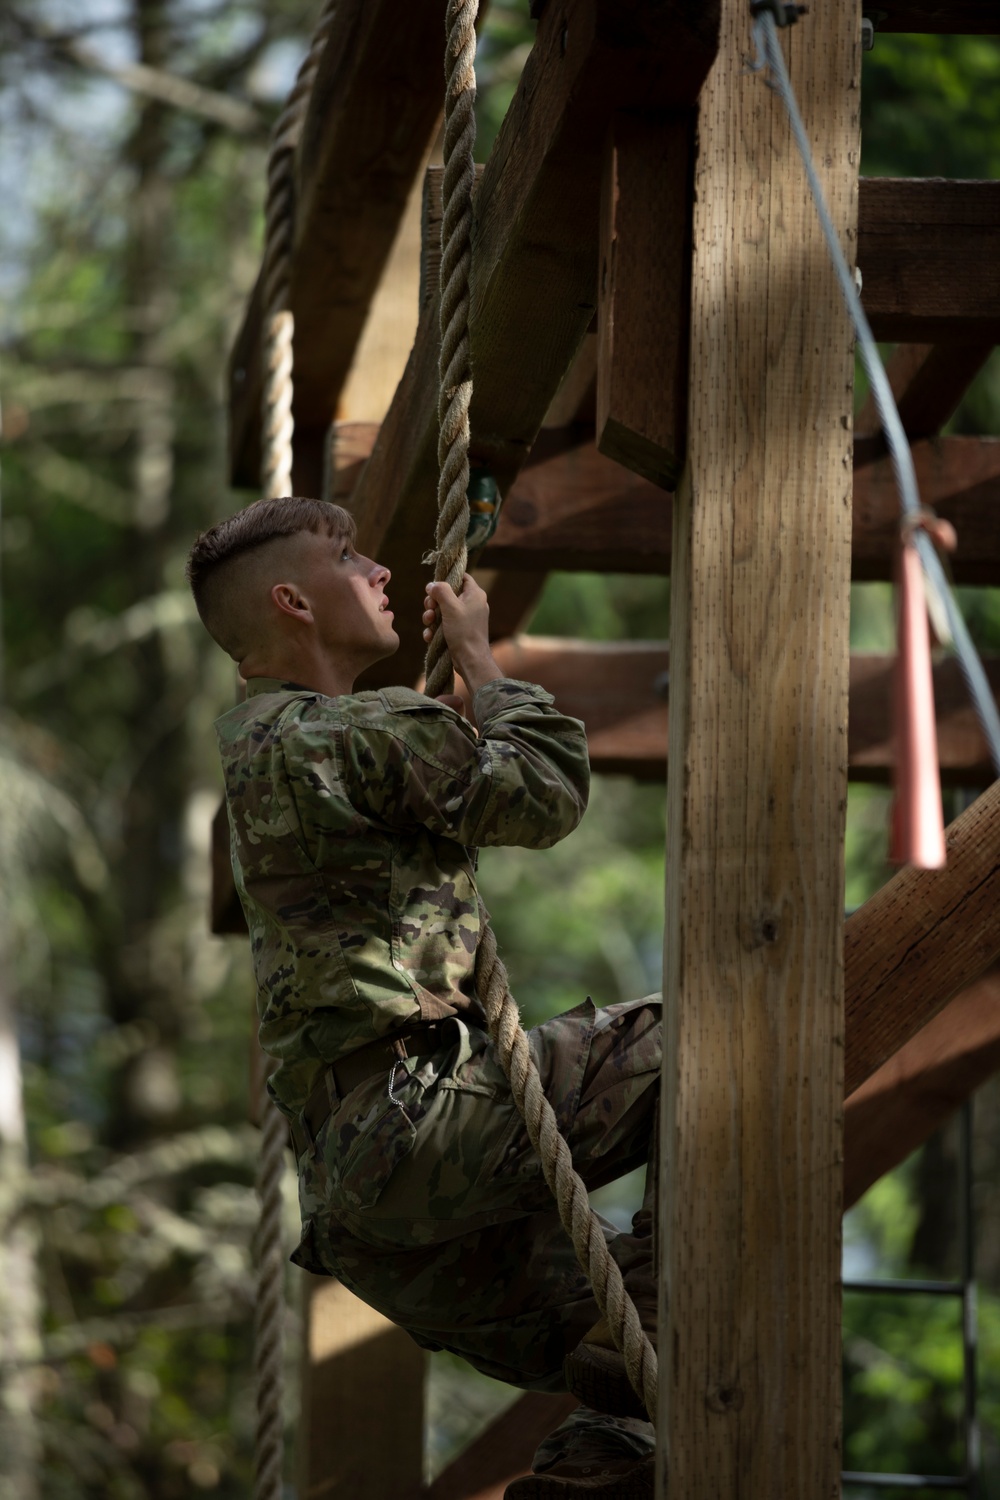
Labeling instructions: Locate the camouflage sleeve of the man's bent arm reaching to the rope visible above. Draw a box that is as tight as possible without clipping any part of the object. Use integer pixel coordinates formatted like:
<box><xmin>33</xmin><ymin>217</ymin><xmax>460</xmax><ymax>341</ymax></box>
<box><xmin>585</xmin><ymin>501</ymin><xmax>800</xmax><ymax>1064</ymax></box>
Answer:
<box><xmin>343</xmin><ymin>678</ymin><xmax>591</xmax><ymax>849</ymax></box>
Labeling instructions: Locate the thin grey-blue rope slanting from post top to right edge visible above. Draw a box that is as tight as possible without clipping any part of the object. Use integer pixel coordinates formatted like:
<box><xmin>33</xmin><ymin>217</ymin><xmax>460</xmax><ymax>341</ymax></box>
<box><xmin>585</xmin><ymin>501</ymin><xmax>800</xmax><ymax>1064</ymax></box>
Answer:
<box><xmin>751</xmin><ymin>0</ymin><xmax>1000</xmax><ymax>776</ymax></box>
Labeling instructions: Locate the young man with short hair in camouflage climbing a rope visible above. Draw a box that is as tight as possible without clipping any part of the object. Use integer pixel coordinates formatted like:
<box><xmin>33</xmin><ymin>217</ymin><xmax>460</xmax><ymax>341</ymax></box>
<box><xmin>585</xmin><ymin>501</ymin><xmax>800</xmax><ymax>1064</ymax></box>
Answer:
<box><xmin>189</xmin><ymin>500</ymin><xmax>660</xmax><ymax>1500</ymax></box>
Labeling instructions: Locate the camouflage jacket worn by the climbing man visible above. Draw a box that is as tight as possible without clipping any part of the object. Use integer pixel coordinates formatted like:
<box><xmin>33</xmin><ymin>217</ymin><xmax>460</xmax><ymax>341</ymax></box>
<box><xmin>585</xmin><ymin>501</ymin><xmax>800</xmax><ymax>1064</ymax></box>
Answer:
<box><xmin>216</xmin><ymin>678</ymin><xmax>589</xmax><ymax>1115</ymax></box>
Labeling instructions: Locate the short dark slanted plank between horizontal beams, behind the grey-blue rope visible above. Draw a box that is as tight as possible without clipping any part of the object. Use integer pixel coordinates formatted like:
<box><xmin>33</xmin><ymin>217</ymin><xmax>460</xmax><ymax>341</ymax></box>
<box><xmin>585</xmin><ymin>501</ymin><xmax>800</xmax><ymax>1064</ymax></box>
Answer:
<box><xmin>855</xmin><ymin>342</ymin><xmax>993</xmax><ymax>443</ymax></box>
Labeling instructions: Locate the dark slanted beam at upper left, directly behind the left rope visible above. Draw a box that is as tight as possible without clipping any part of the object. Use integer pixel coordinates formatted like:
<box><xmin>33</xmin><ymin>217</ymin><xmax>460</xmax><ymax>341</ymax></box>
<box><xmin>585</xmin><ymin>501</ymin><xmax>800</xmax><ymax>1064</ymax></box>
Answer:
<box><xmin>229</xmin><ymin>0</ymin><xmax>444</xmax><ymax>486</ymax></box>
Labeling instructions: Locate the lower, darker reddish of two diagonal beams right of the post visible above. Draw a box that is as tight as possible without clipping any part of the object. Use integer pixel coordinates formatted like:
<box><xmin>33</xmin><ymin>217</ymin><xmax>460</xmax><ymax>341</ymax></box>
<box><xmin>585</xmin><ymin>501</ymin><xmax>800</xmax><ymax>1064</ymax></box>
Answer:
<box><xmin>844</xmin><ymin>969</ymin><xmax>1000</xmax><ymax>1209</ymax></box>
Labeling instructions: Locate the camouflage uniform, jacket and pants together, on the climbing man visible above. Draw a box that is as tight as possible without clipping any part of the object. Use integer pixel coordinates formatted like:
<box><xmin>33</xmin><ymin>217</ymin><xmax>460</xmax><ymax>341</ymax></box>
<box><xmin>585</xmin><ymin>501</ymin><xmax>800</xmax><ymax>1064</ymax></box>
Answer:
<box><xmin>217</xmin><ymin>680</ymin><xmax>660</xmax><ymax>1391</ymax></box>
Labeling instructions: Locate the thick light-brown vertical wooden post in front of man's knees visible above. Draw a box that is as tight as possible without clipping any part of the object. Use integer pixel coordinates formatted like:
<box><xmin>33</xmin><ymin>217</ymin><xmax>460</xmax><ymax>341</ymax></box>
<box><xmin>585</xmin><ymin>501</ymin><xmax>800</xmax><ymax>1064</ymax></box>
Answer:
<box><xmin>658</xmin><ymin>0</ymin><xmax>861</xmax><ymax>1500</ymax></box>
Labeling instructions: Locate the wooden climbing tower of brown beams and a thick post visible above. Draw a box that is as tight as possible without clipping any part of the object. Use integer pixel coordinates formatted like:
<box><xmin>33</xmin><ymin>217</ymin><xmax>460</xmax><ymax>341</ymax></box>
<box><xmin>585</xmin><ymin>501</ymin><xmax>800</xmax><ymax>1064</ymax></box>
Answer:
<box><xmin>216</xmin><ymin>0</ymin><xmax>1000</xmax><ymax>1500</ymax></box>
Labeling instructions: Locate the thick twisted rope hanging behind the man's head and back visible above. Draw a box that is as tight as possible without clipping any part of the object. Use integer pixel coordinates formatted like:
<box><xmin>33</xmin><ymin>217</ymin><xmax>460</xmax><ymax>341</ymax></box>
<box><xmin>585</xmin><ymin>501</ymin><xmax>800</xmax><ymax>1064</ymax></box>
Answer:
<box><xmin>253</xmin><ymin>11</ymin><xmax>337</xmax><ymax>1500</ymax></box>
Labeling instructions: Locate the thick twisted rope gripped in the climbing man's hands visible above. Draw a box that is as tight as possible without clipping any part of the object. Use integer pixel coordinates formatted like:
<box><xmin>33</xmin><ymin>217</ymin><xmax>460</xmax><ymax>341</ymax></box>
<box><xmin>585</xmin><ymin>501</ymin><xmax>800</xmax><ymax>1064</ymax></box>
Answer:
<box><xmin>424</xmin><ymin>0</ymin><xmax>657</xmax><ymax>1419</ymax></box>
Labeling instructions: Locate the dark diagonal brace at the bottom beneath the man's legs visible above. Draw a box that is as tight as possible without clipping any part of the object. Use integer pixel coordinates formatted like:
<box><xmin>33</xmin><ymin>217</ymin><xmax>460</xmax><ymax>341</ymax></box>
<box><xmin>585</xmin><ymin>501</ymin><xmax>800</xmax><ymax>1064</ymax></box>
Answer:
<box><xmin>406</xmin><ymin>1391</ymin><xmax>579</xmax><ymax>1500</ymax></box>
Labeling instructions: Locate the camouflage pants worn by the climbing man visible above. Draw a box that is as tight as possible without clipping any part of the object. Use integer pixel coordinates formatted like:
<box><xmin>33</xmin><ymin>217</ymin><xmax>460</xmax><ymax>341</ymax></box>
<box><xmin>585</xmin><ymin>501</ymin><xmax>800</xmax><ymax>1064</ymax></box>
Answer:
<box><xmin>294</xmin><ymin>996</ymin><xmax>661</xmax><ymax>1391</ymax></box>
